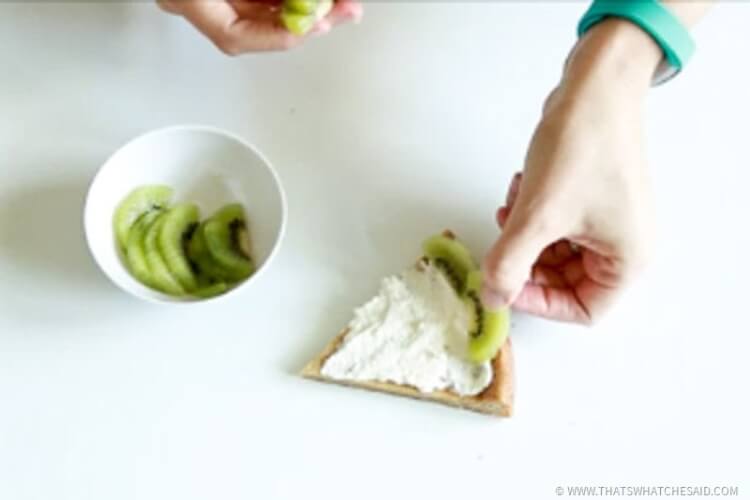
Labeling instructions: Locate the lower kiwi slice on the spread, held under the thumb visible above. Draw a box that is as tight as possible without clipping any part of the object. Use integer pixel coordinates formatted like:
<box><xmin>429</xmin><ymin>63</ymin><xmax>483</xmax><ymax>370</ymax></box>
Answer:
<box><xmin>464</xmin><ymin>270</ymin><xmax>510</xmax><ymax>363</ymax></box>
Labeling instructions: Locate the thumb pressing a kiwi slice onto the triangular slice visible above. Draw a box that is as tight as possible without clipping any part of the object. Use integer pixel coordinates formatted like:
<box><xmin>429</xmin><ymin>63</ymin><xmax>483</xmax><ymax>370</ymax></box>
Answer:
<box><xmin>482</xmin><ymin>211</ymin><xmax>556</xmax><ymax>309</ymax></box>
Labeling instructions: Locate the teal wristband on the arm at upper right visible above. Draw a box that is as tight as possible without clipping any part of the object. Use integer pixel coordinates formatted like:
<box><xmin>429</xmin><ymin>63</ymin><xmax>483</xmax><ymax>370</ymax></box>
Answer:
<box><xmin>578</xmin><ymin>0</ymin><xmax>695</xmax><ymax>83</ymax></box>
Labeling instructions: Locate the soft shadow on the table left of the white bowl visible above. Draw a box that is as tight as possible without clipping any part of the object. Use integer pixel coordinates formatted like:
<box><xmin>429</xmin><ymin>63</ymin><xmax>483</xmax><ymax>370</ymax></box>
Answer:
<box><xmin>0</xmin><ymin>178</ymin><xmax>123</xmax><ymax>320</ymax></box>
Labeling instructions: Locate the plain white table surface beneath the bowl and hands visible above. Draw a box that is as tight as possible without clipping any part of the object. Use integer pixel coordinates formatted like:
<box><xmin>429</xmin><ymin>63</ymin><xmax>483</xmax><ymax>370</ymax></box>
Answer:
<box><xmin>0</xmin><ymin>2</ymin><xmax>750</xmax><ymax>500</ymax></box>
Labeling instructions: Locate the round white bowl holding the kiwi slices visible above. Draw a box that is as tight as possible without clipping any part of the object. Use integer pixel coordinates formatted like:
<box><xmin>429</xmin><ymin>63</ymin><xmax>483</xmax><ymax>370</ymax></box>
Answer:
<box><xmin>84</xmin><ymin>126</ymin><xmax>286</xmax><ymax>303</ymax></box>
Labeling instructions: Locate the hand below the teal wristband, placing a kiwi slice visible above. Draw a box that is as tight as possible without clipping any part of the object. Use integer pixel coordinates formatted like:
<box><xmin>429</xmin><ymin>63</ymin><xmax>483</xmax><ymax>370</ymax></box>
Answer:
<box><xmin>482</xmin><ymin>21</ymin><xmax>660</xmax><ymax>323</ymax></box>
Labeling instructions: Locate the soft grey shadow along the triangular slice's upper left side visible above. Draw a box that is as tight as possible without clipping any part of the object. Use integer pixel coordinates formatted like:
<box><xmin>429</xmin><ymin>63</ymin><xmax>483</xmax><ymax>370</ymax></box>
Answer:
<box><xmin>284</xmin><ymin>188</ymin><xmax>498</xmax><ymax>374</ymax></box>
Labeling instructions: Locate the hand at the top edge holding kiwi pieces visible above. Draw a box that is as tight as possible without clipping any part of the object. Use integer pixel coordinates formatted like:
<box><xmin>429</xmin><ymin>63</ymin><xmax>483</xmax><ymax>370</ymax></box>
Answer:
<box><xmin>157</xmin><ymin>0</ymin><xmax>362</xmax><ymax>56</ymax></box>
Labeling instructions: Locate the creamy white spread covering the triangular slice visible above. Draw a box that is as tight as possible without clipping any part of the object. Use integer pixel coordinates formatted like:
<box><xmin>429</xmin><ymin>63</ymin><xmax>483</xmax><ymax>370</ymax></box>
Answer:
<box><xmin>321</xmin><ymin>264</ymin><xmax>492</xmax><ymax>396</ymax></box>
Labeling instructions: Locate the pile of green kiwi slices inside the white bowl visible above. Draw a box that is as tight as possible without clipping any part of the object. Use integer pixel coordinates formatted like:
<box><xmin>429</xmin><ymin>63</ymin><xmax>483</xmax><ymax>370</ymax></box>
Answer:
<box><xmin>114</xmin><ymin>185</ymin><xmax>255</xmax><ymax>297</ymax></box>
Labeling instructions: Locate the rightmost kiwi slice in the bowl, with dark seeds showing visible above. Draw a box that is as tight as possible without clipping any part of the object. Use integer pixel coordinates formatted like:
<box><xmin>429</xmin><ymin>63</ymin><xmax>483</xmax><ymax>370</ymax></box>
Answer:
<box><xmin>203</xmin><ymin>203</ymin><xmax>255</xmax><ymax>281</ymax></box>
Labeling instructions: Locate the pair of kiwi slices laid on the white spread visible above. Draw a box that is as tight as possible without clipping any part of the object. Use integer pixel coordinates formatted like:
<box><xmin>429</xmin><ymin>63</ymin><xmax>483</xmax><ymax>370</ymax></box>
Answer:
<box><xmin>422</xmin><ymin>231</ymin><xmax>510</xmax><ymax>363</ymax></box>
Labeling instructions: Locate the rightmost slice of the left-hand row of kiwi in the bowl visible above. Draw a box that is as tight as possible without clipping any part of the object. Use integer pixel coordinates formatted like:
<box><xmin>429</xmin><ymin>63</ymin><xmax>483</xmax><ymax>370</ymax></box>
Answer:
<box><xmin>157</xmin><ymin>203</ymin><xmax>200</xmax><ymax>292</ymax></box>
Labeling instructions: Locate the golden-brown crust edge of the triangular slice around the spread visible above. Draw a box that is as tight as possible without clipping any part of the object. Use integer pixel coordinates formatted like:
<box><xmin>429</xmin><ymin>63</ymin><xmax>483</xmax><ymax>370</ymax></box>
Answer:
<box><xmin>301</xmin><ymin>248</ymin><xmax>514</xmax><ymax>417</ymax></box>
